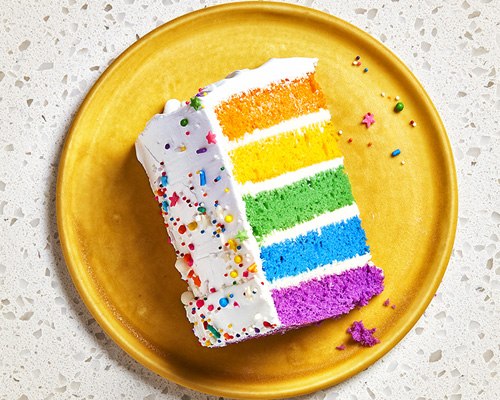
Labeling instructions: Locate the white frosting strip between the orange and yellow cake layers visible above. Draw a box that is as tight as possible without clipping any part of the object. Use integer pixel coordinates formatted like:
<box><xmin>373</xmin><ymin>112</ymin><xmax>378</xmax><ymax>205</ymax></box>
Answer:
<box><xmin>228</xmin><ymin>109</ymin><xmax>331</xmax><ymax>150</ymax></box>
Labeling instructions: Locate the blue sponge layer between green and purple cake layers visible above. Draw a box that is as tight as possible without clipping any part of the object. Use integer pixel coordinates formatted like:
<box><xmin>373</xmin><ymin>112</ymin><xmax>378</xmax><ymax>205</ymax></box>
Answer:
<box><xmin>260</xmin><ymin>216</ymin><xmax>370</xmax><ymax>282</ymax></box>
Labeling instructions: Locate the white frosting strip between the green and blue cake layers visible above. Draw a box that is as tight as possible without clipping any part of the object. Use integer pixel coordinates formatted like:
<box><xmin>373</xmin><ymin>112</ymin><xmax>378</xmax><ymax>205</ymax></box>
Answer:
<box><xmin>261</xmin><ymin>203</ymin><xmax>359</xmax><ymax>247</ymax></box>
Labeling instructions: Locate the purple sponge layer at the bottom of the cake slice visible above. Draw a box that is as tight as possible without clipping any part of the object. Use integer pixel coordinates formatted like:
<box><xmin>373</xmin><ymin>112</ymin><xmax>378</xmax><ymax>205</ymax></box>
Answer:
<box><xmin>272</xmin><ymin>264</ymin><xmax>384</xmax><ymax>328</ymax></box>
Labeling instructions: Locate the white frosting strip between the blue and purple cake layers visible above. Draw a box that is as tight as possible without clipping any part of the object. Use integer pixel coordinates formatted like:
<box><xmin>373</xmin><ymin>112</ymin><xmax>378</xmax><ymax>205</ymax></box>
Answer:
<box><xmin>271</xmin><ymin>253</ymin><xmax>371</xmax><ymax>289</ymax></box>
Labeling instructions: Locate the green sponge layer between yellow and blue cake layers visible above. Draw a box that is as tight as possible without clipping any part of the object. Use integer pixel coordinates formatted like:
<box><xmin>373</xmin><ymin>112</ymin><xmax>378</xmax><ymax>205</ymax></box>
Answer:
<box><xmin>243</xmin><ymin>166</ymin><xmax>354</xmax><ymax>240</ymax></box>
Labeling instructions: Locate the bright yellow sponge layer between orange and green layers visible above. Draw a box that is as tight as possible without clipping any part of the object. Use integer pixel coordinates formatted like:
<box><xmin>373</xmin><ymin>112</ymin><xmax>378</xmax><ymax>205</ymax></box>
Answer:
<box><xmin>229</xmin><ymin>122</ymin><xmax>342</xmax><ymax>183</ymax></box>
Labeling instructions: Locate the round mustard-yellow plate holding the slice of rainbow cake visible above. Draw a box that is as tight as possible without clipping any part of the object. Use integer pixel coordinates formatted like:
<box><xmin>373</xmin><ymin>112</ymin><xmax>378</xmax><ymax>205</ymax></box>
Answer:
<box><xmin>57</xmin><ymin>2</ymin><xmax>457</xmax><ymax>398</ymax></box>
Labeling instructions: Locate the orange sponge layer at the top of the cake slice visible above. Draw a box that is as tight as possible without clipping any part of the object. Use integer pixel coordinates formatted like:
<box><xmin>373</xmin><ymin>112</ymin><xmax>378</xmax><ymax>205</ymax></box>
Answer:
<box><xmin>215</xmin><ymin>73</ymin><xmax>327</xmax><ymax>140</ymax></box>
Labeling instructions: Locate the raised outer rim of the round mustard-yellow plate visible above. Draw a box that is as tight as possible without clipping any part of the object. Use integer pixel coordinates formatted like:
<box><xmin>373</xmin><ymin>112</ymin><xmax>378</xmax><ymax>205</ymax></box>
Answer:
<box><xmin>56</xmin><ymin>1</ymin><xmax>458</xmax><ymax>399</ymax></box>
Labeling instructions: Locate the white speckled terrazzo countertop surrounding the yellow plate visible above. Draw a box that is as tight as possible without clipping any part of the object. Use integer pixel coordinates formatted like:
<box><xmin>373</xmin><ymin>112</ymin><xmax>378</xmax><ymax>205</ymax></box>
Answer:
<box><xmin>0</xmin><ymin>0</ymin><xmax>500</xmax><ymax>400</ymax></box>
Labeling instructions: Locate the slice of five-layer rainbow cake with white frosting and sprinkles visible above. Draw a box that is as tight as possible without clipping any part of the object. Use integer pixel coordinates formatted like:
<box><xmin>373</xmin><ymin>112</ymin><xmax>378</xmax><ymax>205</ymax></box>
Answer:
<box><xmin>136</xmin><ymin>58</ymin><xmax>384</xmax><ymax>347</ymax></box>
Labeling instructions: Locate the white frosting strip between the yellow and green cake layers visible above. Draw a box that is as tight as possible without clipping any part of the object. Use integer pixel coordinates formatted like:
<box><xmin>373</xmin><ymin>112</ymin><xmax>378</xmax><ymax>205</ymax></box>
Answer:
<box><xmin>239</xmin><ymin>157</ymin><xmax>344</xmax><ymax>196</ymax></box>
